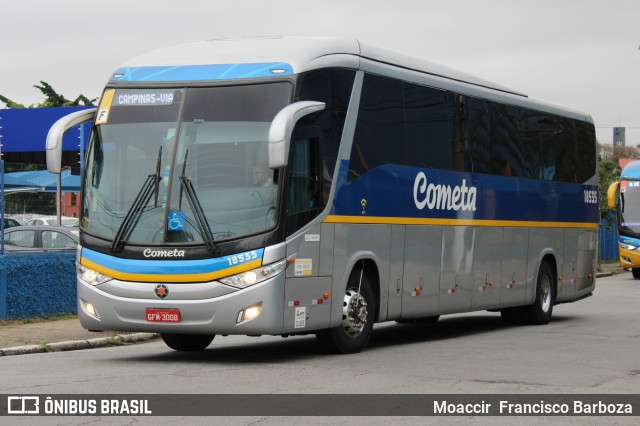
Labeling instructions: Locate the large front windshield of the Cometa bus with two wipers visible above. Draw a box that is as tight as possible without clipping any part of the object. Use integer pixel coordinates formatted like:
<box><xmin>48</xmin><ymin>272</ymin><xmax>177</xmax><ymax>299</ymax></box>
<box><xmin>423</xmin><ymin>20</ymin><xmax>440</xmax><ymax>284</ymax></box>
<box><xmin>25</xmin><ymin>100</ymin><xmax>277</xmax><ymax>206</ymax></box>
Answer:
<box><xmin>81</xmin><ymin>82</ymin><xmax>292</xmax><ymax>245</ymax></box>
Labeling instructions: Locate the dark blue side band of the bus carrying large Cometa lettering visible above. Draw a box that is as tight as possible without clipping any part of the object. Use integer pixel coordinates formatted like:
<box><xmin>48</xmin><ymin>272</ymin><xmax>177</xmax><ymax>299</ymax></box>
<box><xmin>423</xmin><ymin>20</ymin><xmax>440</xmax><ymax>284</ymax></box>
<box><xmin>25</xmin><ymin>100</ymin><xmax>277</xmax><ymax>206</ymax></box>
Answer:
<box><xmin>330</xmin><ymin>160</ymin><xmax>599</xmax><ymax>226</ymax></box>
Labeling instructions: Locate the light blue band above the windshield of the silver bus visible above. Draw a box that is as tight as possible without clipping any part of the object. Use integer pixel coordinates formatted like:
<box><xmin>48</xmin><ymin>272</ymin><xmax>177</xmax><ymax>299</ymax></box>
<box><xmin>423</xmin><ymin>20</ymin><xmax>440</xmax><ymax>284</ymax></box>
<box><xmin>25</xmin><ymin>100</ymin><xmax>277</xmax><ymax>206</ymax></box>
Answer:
<box><xmin>111</xmin><ymin>62</ymin><xmax>293</xmax><ymax>82</ymax></box>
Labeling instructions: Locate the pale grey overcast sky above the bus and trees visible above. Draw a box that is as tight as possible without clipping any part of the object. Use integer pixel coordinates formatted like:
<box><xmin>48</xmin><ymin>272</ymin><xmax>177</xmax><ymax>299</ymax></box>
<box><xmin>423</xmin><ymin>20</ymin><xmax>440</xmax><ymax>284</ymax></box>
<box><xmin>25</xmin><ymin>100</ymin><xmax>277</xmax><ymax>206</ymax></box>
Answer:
<box><xmin>0</xmin><ymin>0</ymin><xmax>640</xmax><ymax>146</ymax></box>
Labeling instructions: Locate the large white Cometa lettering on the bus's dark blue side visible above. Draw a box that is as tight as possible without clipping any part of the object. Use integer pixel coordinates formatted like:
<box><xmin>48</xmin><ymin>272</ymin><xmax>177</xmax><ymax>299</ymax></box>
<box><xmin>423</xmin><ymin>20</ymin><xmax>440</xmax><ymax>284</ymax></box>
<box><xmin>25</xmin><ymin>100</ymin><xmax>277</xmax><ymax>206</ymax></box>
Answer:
<box><xmin>413</xmin><ymin>172</ymin><xmax>478</xmax><ymax>212</ymax></box>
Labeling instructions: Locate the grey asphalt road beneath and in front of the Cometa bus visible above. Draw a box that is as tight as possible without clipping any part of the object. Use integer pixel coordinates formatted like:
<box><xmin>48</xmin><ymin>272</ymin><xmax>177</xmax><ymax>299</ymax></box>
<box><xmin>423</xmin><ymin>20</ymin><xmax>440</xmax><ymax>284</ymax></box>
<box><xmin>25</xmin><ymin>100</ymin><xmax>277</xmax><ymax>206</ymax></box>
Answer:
<box><xmin>0</xmin><ymin>273</ymin><xmax>640</xmax><ymax>425</ymax></box>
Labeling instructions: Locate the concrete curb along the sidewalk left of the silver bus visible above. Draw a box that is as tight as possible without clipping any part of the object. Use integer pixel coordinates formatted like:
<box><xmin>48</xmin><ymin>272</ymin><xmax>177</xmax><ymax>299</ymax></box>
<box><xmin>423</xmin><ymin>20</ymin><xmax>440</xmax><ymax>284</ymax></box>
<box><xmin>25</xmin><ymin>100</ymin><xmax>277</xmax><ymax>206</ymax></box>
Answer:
<box><xmin>0</xmin><ymin>333</ymin><xmax>160</xmax><ymax>356</ymax></box>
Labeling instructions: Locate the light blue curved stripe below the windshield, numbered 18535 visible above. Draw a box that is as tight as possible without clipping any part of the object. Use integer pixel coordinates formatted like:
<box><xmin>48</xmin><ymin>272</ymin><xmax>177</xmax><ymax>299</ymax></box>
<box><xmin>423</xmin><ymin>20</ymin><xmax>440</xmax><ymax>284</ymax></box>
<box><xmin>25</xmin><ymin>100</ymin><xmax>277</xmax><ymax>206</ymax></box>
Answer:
<box><xmin>82</xmin><ymin>248</ymin><xmax>264</xmax><ymax>276</ymax></box>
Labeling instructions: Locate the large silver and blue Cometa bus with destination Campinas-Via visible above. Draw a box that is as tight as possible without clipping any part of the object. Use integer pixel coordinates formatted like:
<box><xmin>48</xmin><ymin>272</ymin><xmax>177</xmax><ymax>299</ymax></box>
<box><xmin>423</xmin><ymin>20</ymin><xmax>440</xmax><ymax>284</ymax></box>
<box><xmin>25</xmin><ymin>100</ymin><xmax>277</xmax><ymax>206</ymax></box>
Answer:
<box><xmin>47</xmin><ymin>37</ymin><xmax>598</xmax><ymax>353</ymax></box>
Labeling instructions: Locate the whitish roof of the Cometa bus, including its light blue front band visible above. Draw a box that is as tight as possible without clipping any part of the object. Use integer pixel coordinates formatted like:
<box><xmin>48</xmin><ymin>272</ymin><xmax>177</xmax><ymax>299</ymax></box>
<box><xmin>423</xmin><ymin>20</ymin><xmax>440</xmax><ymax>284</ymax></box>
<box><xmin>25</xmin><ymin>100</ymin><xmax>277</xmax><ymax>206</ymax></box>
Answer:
<box><xmin>110</xmin><ymin>36</ymin><xmax>593</xmax><ymax>123</ymax></box>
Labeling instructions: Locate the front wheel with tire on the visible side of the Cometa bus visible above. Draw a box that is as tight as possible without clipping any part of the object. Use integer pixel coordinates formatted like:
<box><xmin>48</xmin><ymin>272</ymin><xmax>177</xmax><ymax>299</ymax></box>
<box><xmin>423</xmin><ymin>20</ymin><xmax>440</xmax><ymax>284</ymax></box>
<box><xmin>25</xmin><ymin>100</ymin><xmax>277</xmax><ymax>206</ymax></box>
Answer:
<box><xmin>316</xmin><ymin>273</ymin><xmax>376</xmax><ymax>354</ymax></box>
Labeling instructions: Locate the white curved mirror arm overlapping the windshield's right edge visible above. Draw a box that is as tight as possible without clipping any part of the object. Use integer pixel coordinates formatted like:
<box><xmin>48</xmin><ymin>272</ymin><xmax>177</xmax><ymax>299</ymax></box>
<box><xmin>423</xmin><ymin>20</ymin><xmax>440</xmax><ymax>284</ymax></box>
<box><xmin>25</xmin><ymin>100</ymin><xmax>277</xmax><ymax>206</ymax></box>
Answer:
<box><xmin>268</xmin><ymin>101</ymin><xmax>325</xmax><ymax>169</ymax></box>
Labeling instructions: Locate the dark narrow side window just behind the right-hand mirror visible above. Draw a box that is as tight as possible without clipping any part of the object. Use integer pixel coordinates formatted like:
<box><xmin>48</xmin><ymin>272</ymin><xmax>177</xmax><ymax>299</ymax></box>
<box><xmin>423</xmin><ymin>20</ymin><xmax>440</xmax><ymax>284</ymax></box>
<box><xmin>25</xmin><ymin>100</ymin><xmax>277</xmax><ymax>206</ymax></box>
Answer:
<box><xmin>286</xmin><ymin>130</ymin><xmax>324</xmax><ymax>235</ymax></box>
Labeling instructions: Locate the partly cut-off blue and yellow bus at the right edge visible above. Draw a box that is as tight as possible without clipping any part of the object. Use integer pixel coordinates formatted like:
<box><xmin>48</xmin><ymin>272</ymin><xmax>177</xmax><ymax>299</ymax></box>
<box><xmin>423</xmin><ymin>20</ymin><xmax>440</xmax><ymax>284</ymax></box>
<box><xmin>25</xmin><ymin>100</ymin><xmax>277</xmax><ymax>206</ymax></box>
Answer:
<box><xmin>607</xmin><ymin>161</ymin><xmax>640</xmax><ymax>279</ymax></box>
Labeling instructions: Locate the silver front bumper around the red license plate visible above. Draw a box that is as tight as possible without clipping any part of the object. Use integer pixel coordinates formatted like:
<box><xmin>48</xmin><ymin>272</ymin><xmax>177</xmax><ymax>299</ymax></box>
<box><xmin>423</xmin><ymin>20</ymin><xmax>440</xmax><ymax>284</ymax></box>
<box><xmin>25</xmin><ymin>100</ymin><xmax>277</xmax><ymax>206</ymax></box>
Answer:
<box><xmin>78</xmin><ymin>273</ymin><xmax>285</xmax><ymax>335</ymax></box>
